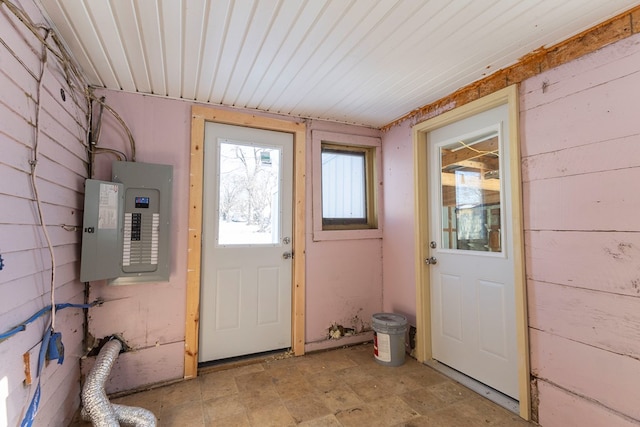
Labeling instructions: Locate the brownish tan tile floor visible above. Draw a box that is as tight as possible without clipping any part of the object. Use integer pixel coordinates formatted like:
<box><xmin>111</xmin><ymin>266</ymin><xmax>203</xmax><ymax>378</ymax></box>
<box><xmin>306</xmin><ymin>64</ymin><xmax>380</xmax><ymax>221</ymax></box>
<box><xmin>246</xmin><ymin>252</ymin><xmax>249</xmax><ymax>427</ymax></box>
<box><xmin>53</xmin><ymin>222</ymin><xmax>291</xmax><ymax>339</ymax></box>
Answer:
<box><xmin>72</xmin><ymin>344</ymin><xmax>534</xmax><ymax>427</ymax></box>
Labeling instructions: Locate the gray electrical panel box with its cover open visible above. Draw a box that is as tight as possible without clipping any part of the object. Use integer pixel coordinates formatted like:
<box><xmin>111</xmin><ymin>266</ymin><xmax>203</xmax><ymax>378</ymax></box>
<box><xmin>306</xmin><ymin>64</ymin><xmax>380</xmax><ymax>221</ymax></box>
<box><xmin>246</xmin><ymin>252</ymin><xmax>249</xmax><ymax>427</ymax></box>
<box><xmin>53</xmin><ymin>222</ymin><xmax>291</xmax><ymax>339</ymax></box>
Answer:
<box><xmin>80</xmin><ymin>162</ymin><xmax>173</xmax><ymax>285</ymax></box>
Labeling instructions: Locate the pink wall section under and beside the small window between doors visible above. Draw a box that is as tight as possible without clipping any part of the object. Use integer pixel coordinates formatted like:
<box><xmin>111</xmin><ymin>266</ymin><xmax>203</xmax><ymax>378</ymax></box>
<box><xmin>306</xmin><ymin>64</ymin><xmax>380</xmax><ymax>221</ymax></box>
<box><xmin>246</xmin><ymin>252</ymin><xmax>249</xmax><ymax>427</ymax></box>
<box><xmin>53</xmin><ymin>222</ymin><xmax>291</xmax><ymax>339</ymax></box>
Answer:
<box><xmin>305</xmin><ymin>120</ymin><xmax>384</xmax><ymax>351</ymax></box>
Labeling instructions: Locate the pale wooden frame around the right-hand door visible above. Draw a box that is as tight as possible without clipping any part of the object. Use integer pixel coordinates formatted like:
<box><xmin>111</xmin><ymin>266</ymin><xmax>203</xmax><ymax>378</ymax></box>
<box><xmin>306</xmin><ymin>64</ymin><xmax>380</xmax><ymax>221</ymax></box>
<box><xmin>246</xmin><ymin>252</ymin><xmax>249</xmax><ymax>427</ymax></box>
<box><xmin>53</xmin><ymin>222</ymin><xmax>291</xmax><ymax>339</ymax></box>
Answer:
<box><xmin>413</xmin><ymin>85</ymin><xmax>531</xmax><ymax>420</ymax></box>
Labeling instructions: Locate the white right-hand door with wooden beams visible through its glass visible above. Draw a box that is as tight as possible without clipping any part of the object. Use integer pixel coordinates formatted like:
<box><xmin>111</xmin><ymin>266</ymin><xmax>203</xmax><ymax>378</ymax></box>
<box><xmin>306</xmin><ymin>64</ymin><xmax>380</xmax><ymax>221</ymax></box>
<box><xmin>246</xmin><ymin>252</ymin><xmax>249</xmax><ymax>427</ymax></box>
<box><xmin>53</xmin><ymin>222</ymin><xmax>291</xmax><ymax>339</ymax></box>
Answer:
<box><xmin>425</xmin><ymin>104</ymin><xmax>518</xmax><ymax>400</ymax></box>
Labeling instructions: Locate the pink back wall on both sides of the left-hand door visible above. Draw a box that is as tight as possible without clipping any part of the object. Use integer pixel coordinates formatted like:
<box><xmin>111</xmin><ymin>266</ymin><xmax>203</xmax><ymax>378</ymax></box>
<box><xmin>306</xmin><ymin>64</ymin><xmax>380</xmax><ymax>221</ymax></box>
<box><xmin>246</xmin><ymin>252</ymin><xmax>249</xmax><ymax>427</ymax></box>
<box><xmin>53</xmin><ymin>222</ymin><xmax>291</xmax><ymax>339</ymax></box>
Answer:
<box><xmin>83</xmin><ymin>91</ymin><xmax>382</xmax><ymax>392</ymax></box>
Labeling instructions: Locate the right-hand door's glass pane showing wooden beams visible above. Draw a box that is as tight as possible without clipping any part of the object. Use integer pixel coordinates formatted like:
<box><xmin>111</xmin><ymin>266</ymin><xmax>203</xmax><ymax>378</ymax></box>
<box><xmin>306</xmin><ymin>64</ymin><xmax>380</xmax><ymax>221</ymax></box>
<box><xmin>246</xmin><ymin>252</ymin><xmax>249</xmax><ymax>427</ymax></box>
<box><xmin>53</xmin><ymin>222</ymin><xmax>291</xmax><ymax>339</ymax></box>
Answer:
<box><xmin>440</xmin><ymin>132</ymin><xmax>502</xmax><ymax>252</ymax></box>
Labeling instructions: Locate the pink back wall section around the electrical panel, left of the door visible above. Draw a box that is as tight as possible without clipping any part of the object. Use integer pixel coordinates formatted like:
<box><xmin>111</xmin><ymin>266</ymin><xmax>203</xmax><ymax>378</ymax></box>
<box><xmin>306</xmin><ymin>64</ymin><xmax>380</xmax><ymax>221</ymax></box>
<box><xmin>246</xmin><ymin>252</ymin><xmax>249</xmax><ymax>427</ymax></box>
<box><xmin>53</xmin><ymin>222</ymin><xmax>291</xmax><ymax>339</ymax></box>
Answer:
<box><xmin>82</xmin><ymin>91</ymin><xmax>191</xmax><ymax>392</ymax></box>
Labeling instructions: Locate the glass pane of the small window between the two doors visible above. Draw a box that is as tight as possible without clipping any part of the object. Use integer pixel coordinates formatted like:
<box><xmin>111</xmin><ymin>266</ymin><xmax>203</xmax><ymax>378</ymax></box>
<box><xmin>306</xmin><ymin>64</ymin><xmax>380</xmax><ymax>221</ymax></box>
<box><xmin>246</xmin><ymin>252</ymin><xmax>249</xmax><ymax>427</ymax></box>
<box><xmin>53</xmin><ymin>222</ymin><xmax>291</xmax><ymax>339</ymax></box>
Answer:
<box><xmin>322</xmin><ymin>150</ymin><xmax>367</xmax><ymax>222</ymax></box>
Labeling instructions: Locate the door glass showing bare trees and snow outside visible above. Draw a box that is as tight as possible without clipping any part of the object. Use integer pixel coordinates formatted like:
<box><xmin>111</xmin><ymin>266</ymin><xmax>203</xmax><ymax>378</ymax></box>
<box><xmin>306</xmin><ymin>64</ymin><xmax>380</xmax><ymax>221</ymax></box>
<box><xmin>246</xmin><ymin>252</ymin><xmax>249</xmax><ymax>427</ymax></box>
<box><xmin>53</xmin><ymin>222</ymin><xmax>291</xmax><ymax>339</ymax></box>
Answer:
<box><xmin>218</xmin><ymin>140</ymin><xmax>280</xmax><ymax>245</ymax></box>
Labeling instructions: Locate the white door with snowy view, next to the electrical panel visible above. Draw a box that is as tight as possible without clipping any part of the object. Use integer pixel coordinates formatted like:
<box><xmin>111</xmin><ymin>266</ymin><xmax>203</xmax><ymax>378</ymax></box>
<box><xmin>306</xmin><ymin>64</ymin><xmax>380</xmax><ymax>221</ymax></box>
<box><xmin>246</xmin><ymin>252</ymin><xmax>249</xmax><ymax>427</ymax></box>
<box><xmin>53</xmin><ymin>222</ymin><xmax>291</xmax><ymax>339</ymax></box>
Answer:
<box><xmin>198</xmin><ymin>123</ymin><xmax>293</xmax><ymax>362</ymax></box>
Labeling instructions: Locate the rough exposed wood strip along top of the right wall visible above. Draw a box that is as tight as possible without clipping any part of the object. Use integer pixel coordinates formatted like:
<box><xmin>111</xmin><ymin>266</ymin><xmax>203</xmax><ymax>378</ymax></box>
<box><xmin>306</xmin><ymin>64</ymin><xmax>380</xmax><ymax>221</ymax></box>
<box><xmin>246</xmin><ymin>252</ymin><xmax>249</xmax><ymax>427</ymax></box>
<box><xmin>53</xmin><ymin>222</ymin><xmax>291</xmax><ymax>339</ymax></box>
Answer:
<box><xmin>381</xmin><ymin>6</ymin><xmax>640</xmax><ymax>132</ymax></box>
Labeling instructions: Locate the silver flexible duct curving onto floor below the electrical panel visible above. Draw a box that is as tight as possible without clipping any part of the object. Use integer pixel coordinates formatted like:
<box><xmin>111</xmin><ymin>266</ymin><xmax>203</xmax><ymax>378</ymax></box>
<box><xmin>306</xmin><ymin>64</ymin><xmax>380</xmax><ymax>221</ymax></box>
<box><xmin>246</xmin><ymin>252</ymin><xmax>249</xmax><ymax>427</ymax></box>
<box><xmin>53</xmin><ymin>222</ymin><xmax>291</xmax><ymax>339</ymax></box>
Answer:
<box><xmin>82</xmin><ymin>339</ymin><xmax>156</xmax><ymax>427</ymax></box>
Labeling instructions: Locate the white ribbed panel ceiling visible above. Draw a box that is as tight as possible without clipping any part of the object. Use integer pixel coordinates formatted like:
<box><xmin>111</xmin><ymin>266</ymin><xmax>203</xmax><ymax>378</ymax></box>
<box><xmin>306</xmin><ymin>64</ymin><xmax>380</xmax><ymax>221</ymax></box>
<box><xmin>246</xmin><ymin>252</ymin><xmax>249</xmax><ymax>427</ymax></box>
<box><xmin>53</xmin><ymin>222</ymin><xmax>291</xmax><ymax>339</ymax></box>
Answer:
<box><xmin>40</xmin><ymin>0</ymin><xmax>640</xmax><ymax>127</ymax></box>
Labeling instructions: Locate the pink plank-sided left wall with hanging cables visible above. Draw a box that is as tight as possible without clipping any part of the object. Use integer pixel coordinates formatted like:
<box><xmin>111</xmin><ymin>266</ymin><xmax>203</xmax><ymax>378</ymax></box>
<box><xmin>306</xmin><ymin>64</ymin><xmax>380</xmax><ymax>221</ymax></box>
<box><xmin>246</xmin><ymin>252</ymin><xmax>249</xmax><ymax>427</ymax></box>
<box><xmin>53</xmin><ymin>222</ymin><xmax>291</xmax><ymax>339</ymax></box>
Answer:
<box><xmin>0</xmin><ymin>0</ymin><xmax>87</xmax><ymax>426</ymax></box>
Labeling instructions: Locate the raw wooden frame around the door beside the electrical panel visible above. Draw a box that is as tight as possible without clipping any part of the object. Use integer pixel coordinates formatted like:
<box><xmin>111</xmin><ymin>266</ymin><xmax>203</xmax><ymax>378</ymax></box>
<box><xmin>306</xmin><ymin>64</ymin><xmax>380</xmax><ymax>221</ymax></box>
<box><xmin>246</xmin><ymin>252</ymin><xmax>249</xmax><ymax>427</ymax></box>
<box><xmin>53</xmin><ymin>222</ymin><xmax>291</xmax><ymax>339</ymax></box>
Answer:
<box><xmin>184</xmin><ymin>105</ymin><xmax>306</xmax><ymax>378</ymax></box>
